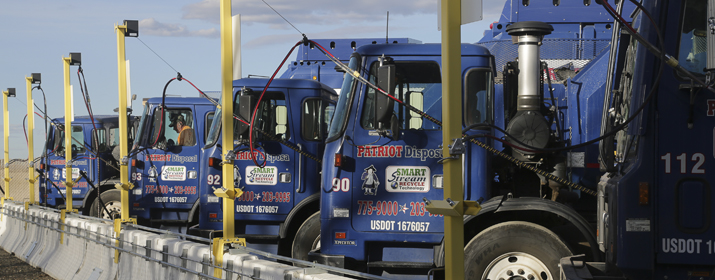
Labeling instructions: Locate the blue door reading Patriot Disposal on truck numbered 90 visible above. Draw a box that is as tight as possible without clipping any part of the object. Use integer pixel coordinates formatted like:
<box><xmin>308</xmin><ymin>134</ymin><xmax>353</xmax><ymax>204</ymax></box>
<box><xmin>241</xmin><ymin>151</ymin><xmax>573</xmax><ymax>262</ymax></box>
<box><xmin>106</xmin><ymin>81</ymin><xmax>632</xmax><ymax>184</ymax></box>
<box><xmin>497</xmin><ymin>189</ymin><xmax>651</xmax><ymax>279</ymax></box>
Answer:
<box><xmin>350</xmin><ymin>58</ymin><xmax>444</xmax><ymax>233</ymax></box>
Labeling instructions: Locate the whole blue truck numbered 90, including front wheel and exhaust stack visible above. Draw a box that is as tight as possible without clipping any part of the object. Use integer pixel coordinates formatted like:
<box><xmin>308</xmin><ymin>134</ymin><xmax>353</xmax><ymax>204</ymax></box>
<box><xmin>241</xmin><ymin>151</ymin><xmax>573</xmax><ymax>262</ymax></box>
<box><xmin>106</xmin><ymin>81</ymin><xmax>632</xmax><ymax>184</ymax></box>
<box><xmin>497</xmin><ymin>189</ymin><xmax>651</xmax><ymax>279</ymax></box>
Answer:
<box><xmin>309</xmin><ymin>3</ymin><xmax>636</xmax><ymax>279</ymax></box>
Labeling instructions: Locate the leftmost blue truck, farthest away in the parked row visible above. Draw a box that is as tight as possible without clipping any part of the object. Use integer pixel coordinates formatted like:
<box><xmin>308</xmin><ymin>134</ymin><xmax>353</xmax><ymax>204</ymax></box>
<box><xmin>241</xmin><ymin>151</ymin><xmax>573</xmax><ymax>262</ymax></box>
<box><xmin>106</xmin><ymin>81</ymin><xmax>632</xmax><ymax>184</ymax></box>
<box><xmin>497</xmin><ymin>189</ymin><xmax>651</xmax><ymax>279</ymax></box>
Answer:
<box><xmin>39</xmin><ymin>115</ymin><xmax>137</xmax><ymax>217</ymax></box>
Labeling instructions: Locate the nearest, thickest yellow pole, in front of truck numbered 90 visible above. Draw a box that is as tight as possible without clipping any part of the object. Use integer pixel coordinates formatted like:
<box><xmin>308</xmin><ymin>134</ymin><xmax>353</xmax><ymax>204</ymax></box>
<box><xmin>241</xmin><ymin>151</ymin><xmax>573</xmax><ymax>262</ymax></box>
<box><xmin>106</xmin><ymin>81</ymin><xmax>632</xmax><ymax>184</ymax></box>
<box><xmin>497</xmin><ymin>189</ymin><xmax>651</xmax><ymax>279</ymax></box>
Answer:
<box><xmin>441</xmin><ymin>0</ymin><xmax>464</xmax><ymax>279</ymax></box>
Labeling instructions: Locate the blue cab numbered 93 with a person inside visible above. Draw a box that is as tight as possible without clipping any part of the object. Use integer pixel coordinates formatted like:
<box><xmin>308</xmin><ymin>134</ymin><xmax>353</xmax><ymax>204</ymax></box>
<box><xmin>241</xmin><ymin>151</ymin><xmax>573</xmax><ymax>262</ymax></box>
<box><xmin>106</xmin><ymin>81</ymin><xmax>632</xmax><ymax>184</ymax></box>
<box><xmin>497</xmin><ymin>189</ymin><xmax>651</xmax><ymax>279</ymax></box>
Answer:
<box><xmin>129</xmin><ymin>97</ymin><xmax>216</xmax><ymax>233</ymax></box>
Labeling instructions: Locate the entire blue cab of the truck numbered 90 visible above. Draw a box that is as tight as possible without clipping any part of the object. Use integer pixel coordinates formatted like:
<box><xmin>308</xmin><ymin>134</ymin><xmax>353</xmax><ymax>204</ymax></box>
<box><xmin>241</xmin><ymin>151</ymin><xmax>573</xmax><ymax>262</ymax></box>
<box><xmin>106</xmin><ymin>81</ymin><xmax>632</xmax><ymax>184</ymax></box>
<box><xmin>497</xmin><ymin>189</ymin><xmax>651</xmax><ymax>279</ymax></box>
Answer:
<box><xmin>311</xmin><ymin>44</ymin><xmax>494</xmax><ymax>271</ymax></box>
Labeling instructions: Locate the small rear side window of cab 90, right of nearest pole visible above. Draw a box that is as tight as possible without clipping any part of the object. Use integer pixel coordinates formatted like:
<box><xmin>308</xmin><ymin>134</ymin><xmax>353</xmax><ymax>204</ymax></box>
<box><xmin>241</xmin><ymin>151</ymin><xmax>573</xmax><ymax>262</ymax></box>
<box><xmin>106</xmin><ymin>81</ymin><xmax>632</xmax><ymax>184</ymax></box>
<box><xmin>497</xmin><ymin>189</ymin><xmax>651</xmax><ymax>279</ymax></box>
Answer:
<box><xmin>464</xmin><ymin>69</ymin><xmax>493</xmax><ymax>126</ymax></box>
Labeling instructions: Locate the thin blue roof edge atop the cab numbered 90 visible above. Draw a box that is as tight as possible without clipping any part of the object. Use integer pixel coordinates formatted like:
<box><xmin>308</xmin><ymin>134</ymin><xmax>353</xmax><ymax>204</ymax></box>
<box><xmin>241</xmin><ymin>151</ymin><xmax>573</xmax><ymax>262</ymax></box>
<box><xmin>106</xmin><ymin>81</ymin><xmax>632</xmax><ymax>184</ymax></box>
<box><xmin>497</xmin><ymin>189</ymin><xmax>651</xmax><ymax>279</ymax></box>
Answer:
<box><xmin>358</xmin><ymin>43</ymin><xmax>491</xmax><ymax>56</ymax></box>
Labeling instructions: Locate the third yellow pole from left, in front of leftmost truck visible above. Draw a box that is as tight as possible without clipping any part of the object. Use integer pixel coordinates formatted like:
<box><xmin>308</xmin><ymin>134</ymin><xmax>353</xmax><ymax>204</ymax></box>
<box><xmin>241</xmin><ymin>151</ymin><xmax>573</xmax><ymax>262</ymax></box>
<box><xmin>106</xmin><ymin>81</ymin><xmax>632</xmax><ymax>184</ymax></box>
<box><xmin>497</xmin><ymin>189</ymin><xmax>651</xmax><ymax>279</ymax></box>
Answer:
<box><xmin>62</xmin><ymin>57</ymin><xmax>74</xmax><ymax>212</ymax></box>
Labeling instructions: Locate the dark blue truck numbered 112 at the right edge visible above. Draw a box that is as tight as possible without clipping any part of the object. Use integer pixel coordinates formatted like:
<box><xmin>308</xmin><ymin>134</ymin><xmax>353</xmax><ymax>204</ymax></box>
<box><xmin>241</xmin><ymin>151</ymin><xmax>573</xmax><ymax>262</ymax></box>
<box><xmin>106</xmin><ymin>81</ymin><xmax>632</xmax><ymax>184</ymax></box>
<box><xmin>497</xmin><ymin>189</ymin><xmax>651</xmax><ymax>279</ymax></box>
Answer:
<box><xmin>561</xmin><ymin>0</ymin><xmax>715</xmax><ymax>279</ymax></box>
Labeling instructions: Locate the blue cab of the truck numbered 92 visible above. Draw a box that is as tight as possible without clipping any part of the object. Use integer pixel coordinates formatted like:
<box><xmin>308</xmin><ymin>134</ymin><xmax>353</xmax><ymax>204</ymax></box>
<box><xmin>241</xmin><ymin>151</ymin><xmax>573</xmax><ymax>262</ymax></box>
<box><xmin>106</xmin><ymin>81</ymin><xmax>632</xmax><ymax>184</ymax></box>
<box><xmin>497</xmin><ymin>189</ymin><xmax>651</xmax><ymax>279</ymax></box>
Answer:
<box><xmin>198</xmin><ymin>78</ymin><xmax>337</xmax><ymax>258</ymax></box>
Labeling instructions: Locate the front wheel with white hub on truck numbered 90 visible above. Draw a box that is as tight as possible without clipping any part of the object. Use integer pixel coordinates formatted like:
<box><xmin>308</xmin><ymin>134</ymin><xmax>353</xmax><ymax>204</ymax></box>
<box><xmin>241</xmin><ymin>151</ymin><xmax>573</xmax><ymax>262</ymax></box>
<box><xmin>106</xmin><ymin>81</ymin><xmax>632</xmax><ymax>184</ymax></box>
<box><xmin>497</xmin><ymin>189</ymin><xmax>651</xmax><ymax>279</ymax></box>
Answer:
<box><xmin>464</xmin><ymin>221</ymin><xmax>572</xmax><ymax>280</ymax></box>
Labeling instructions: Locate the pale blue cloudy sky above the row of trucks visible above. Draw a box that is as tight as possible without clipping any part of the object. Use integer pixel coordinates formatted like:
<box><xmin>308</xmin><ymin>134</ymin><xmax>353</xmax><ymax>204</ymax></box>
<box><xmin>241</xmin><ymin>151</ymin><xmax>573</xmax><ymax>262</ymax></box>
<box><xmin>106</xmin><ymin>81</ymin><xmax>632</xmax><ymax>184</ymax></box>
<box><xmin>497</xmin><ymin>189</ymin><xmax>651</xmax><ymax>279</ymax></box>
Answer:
<box><xmin>0</xmin><ymin>0</ymin><xmax>507</xmax><ymax>159</ymax></box>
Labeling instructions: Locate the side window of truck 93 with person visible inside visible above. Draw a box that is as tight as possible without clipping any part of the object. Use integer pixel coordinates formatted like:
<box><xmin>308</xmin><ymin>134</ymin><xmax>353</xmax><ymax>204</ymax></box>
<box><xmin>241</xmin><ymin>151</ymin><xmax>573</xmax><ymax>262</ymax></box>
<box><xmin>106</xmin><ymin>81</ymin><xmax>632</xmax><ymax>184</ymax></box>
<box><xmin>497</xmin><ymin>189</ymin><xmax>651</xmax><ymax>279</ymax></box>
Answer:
<box><xmin>149</xmin><ymin>108</ymin><xmax>196</xmax><ymax>148</ymax></box>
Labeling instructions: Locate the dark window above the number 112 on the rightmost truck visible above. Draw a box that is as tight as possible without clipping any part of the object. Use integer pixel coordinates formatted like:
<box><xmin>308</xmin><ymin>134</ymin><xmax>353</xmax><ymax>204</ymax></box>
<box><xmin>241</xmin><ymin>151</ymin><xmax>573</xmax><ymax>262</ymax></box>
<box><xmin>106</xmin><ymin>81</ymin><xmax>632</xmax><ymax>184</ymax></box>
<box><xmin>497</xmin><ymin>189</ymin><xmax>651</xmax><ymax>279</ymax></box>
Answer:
<box><xmin>678</xmin><ymin>0</ymin><xmax>708</xmax><ymax>75</ymax></box>
